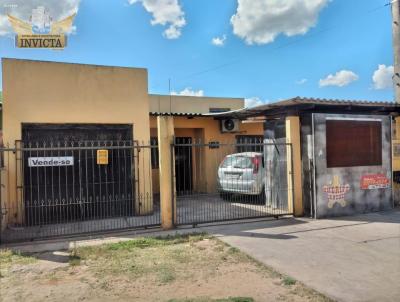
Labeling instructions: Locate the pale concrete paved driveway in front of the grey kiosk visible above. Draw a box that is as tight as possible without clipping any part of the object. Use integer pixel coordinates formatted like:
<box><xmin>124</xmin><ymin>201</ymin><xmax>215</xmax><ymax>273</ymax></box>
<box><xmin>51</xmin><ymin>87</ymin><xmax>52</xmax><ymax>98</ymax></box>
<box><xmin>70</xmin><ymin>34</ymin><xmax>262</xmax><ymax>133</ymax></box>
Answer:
<box><xmin>206</xmin><ymin>211</ymin><xmax>400</xmax><ymax>301</ymax></box>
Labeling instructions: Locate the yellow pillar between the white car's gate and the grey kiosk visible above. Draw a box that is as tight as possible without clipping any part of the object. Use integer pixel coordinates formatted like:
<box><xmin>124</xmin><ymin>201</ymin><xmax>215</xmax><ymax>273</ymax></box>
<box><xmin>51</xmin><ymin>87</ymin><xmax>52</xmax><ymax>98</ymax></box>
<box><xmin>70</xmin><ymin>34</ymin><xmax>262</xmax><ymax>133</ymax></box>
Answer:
<box><xmin>286</xmin><ymin>116</ymin><xmax>304</xmax><ymax>216</ymax></box>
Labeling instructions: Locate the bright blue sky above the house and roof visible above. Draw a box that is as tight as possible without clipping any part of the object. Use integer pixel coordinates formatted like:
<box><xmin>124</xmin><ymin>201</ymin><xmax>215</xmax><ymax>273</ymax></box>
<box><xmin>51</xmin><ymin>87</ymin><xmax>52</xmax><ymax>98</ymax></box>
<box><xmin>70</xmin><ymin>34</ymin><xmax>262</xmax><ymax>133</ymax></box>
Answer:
<box><xmin>0</xmin><ymin>0</ymin><xmax>393</xmax><ymax>104</ymax></box>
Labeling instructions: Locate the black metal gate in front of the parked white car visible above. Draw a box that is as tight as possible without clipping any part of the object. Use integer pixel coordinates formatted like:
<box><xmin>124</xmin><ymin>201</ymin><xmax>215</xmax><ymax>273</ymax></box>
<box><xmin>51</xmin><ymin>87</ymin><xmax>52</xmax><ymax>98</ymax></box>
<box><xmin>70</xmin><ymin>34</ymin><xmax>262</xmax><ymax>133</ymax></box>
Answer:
<box><xmin>171</xmin><ymin>138</ymin><xmax>293</xmax><ymax>225</ymax></box>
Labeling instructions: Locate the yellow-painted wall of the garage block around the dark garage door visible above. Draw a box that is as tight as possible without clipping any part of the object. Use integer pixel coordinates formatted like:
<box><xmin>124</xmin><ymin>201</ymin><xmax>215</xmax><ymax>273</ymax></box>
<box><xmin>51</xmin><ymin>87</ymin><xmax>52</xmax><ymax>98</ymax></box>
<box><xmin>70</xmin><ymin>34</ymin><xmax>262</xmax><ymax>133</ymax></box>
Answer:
<box><xmin>2</xmin><ymin>59</ymin><xmax>152</xmax><ymax>224</ymax></box>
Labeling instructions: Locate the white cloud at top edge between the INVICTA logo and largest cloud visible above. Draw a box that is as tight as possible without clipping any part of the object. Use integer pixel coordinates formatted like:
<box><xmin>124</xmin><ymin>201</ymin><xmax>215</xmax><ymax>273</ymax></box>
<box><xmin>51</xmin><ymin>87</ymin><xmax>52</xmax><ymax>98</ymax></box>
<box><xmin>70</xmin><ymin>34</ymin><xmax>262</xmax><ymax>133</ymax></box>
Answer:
<box><xmin>129</xmin><ymin>0</ymin><xmax>186</xmax><ymax>39</ymax></box>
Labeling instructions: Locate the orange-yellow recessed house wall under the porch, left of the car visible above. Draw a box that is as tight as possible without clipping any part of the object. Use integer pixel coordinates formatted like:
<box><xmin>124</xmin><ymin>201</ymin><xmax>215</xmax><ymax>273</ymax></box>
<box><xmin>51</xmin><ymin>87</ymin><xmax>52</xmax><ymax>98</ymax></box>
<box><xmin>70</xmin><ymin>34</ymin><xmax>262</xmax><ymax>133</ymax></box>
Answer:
<box><xmin>150</xmin><ymin>116</ymin><xmax>264</xmax><ymax>193</ymax></box>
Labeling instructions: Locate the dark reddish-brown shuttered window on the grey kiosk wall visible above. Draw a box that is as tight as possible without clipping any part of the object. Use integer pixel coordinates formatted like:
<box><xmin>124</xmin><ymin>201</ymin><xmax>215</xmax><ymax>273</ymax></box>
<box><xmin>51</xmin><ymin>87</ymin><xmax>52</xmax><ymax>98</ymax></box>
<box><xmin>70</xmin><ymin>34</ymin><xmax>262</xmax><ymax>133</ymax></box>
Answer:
<box><xmin>326</xmin><ymin>120</ymin><xmax>382</xmax><ymax>168</ymax></box>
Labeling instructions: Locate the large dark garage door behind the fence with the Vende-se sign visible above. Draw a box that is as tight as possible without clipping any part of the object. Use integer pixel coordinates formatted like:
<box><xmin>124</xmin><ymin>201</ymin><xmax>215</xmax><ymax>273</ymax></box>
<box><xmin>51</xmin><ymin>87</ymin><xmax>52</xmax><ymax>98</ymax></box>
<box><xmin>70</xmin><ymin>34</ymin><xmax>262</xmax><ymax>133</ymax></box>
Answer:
<box><xmin>22</xmin><ymin>124</ymin><xmax>134</xmax><ymax>225</ymax></box>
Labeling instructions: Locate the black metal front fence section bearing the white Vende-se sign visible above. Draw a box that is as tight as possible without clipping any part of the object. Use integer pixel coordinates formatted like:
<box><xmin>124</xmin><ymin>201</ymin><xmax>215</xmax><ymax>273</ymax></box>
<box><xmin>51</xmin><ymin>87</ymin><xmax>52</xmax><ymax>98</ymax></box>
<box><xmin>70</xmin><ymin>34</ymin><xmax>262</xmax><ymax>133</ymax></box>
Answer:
<box><xmin>0</xmin><ymin>140</ymin><xmax>161</xmax><ymax>242</ymax></box>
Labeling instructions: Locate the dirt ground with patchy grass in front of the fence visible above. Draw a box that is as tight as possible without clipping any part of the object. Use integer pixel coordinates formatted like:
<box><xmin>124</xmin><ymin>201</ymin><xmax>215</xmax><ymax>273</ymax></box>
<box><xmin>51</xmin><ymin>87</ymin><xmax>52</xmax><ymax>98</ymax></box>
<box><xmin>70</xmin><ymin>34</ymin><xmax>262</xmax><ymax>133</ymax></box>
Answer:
<box><xmin>0</xmin><ymin>235</ymin><xmax>329</xmax><ymax>302</ymax></box>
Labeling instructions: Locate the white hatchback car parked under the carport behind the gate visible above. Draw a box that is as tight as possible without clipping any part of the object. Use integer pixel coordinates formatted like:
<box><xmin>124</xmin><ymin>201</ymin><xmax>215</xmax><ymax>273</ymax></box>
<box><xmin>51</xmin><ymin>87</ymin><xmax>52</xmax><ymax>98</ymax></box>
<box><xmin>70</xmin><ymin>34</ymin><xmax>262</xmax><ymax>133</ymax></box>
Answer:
<box><xmin>218</xmin><ymin>152</ymin><xmax>265</xmax><ymax>199</ymax></box>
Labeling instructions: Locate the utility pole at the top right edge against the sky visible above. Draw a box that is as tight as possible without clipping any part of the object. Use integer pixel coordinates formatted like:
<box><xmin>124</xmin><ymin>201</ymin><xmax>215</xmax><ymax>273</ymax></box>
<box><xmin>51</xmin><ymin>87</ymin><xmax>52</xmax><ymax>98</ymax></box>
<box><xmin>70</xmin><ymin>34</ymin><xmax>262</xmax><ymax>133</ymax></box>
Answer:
<box><xmin>391</xmin><ymin>0</ymin><xmax>400</xmax><ymax>104</ymax></box>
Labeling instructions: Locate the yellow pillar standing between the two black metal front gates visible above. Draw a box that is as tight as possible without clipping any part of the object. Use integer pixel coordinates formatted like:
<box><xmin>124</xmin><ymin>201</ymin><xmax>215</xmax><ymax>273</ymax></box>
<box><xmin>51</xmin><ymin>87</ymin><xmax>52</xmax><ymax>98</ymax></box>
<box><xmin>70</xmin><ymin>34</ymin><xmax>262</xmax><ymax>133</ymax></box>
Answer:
<box><xmin>157</xmin><ymin>116</ymin><xmax>176</xmax><ymax>230</ymax></box>
